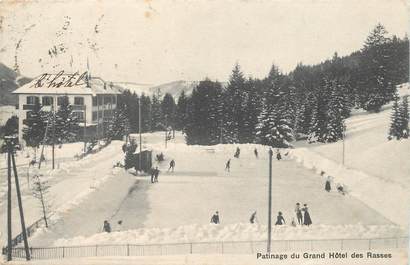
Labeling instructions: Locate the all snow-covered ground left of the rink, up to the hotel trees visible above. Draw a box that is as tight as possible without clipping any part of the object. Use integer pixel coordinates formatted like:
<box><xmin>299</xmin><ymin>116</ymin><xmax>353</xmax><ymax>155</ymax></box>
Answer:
<box><xmin>0</xmin><ymin>141</ymin><xmax>123</xmax><ymax>242</ymax></box>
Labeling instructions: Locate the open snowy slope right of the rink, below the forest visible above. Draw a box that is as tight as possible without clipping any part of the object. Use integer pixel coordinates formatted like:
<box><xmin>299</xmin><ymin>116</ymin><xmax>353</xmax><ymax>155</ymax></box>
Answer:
<box><xmin>292</xmin><ymin>86</ymin><xmax>410</xmax><ymax>229</ymax></box>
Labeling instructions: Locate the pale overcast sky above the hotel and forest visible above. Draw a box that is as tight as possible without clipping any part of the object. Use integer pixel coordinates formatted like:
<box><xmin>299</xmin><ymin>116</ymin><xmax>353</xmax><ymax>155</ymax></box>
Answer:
<box><xmin>0</xmin><ymin>0</ymin><xmax>409</xmax><ymax>84</ymax></box>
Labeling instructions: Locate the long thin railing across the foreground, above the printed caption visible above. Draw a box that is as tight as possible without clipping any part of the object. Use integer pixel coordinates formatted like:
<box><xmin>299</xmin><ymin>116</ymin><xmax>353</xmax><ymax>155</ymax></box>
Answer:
<box><xmin>3</xmin><ymin>237</ymin><xmax>409</xmax><ymax>259</ymax></box>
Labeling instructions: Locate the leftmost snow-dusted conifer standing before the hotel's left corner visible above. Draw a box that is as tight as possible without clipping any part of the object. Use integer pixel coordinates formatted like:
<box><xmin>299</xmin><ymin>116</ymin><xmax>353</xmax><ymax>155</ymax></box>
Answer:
<box><xmin>23</xmin><ymin>101</ymin><xmax>46</xmax><ymax>150</ymax></box>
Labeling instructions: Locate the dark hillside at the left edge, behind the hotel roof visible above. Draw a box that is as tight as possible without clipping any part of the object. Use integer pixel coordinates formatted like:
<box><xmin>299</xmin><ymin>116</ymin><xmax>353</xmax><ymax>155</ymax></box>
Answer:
<box><xmin>0</xmin><ymin>63</ymin><xmax>31</xmax><ymax>106</ymax></box>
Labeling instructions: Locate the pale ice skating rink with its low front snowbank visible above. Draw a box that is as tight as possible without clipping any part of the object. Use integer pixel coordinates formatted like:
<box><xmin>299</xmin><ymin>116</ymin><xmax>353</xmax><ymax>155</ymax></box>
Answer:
<box><xmin>20</xmin><ymin>133</ymin><xmax>403</xmax><ymax>246</ymax></box>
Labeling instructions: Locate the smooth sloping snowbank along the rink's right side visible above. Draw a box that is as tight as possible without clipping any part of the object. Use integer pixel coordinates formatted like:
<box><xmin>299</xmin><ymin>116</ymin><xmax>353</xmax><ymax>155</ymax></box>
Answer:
<box><xmin>290</xmin><ymin>148</ymin><xmax>410</xmax><ymax>229</ymax></box>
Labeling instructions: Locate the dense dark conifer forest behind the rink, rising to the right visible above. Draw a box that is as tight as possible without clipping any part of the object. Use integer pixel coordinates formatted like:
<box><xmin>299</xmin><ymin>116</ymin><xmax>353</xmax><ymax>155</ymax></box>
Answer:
<box><xmin>116</xmin><ymin>24</ymin><xmax>409</xmax><ymax>147</ymax></box>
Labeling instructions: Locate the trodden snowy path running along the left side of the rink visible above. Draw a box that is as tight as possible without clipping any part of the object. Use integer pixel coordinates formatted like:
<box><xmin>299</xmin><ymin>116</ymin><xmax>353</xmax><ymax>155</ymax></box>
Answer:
<box><xmin>0</xmin><ymin>141</ymin><xmax>123</xmax><ymax>242</ymax></box>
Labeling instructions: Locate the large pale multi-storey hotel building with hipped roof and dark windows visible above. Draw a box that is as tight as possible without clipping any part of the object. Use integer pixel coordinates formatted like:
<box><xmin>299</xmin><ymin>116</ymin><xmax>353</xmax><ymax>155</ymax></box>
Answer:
<box><xmin>13</xmin><ymin>73</ymin><xmax>120</xmax><ymax>143</ymax></box>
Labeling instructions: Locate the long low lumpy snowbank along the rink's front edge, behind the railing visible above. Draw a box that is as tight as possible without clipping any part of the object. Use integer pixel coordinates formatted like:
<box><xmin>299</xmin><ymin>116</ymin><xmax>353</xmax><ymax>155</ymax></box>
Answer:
<box><xmin>54</xmin><ymin>223</ymin><xmax>402</xmax><ymax>246</ymax></box>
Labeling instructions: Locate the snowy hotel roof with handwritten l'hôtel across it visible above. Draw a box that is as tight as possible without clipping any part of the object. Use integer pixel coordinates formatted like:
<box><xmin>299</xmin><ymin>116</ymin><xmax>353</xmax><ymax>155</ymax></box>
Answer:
<box><xmin>13</xmin><ymin>72</ymin><xmax>122</xmax><ymax>96</ymax></box>
